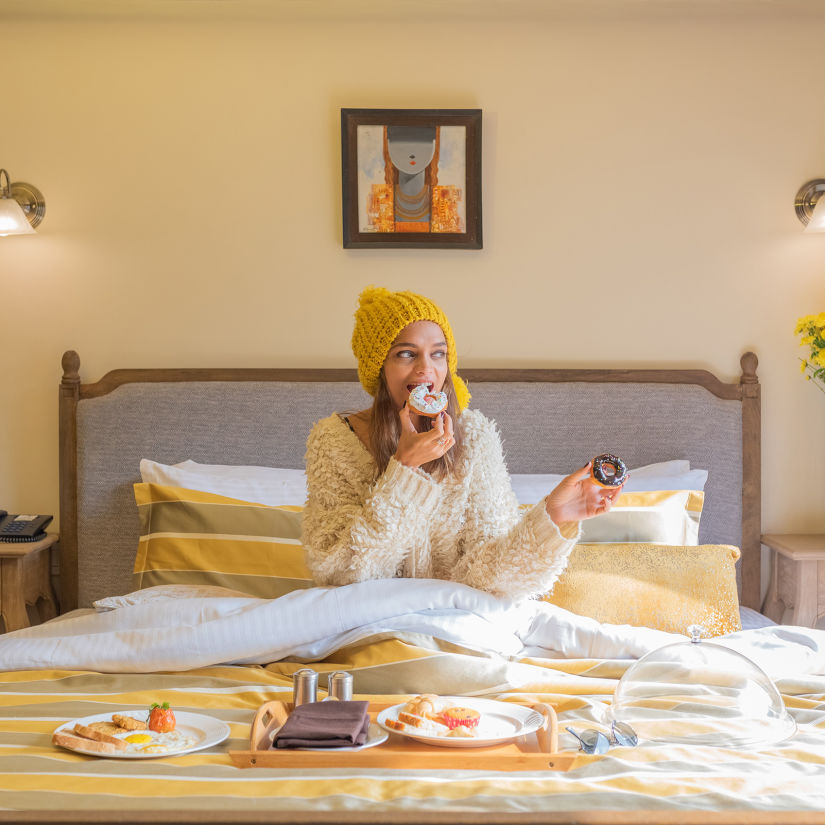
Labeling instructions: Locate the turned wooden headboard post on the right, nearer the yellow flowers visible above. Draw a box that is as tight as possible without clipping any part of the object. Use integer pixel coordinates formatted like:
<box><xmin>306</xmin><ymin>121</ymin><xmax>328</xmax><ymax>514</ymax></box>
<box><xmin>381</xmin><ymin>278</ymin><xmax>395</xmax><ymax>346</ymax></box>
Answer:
<box><xmin>739</xmin><ymin>352</ymin><xmax>762</xmax><ymax>610</ymax></box>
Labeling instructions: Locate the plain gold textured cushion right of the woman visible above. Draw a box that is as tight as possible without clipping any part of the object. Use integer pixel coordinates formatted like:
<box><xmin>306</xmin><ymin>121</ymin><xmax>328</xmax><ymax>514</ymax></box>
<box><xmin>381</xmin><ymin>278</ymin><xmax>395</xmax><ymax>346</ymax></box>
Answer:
<box><xmin>545</xmin><ymin>544</ymin><xmax>742</xmax><ymax>636</ymax></box>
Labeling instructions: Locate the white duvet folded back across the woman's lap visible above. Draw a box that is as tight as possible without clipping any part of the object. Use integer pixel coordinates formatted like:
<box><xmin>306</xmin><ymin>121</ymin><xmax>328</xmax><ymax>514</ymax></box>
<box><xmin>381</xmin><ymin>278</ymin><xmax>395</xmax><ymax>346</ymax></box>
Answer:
<box><xmin>0</xmin><ymin>579</ymin><xmax>825</xmax><ymax>680</ymax></box>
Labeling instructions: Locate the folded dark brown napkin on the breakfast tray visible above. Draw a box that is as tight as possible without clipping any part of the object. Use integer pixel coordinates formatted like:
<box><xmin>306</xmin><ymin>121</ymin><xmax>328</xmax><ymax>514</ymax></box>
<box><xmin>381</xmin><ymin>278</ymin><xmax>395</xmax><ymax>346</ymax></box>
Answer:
<box><xmin>272</xmin><ymin>701</ymin><xmax>370</xmax><ymax>748</ymax></box>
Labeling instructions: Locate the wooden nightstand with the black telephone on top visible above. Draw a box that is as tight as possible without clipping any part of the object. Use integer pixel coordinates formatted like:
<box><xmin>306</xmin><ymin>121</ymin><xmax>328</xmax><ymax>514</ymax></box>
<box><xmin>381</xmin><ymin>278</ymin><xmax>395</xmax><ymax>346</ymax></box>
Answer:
<box><xmin>0</xmin><ymin>533</ymin><xmax>57</xmax><ymax>632</ymax></box>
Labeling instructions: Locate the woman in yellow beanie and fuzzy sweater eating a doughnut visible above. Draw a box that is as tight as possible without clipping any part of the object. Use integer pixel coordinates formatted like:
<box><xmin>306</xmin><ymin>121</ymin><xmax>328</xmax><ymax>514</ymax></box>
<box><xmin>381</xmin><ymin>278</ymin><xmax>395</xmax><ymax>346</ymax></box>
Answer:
<box><xmin>303</xmin><ymin>287</ymin><xmax>621</xmax><ymax>598</ymax></box>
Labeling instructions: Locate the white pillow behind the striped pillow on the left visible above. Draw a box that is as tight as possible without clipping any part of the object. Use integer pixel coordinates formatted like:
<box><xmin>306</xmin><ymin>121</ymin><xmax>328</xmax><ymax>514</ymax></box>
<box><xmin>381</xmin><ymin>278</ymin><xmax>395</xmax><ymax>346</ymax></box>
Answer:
<box><xmin>140</xmin><ymin>458</ymin><xmax>307</xmax><ymax>507</ymax></box>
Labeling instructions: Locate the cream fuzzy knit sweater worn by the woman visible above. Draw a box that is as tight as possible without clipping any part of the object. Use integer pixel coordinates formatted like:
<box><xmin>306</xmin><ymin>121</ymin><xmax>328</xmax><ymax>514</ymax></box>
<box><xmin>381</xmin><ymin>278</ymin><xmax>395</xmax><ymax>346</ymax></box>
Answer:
<box><xmin>303</xmin><ymin>410</ymin><xmax>581</xmax><ymax>598</ymax></box>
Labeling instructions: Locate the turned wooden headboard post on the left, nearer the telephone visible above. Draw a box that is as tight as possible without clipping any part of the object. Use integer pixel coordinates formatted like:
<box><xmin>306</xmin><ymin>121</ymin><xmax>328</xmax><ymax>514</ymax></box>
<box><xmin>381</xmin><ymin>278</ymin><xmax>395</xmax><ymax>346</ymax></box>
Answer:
<box><xmin>59</xmin><ymin>350</ymin><xmax>80</xmax><ymax>613</ymax></box>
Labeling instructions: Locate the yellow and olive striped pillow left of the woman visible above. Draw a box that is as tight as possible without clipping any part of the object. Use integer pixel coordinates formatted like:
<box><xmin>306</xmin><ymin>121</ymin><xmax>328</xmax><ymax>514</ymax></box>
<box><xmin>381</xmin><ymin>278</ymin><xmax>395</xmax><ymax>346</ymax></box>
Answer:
<box><xmin>133</xmin><ymin>483</ymin><xmax>313</xmax><ymax>599</ymax></box>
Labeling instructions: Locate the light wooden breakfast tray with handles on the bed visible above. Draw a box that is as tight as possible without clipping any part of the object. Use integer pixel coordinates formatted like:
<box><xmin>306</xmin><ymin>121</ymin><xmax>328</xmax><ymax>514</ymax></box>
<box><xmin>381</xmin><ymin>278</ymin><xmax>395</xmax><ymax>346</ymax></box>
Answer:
<box><xmin>229</xmin><ymin>701</ymin><xmax>576</xmax><ymax>771</ymax></box>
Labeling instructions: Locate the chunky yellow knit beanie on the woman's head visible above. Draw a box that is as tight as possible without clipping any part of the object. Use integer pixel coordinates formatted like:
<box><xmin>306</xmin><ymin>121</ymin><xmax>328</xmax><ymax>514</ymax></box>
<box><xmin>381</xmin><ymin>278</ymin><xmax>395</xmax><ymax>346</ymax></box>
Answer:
<box><xmin>352</xmin><ymin>286</ymin><xmax>470</xmax><ymax>410</ymax></box>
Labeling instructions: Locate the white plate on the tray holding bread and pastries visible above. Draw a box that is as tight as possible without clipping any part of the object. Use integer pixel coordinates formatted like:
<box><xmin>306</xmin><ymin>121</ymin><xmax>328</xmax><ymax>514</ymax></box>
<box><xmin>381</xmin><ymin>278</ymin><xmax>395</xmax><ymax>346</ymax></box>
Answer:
<box><xmin>376</xmin><ymin>696</ymin><xmax>544</xmax><ymax>748</ymax></box>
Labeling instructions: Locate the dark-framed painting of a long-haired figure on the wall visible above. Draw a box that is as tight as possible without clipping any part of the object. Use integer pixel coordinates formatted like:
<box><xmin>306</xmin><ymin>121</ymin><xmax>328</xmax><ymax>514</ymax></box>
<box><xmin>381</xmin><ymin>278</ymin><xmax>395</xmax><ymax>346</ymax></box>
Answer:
<box><xmin>341</xmin><ymin>109</ymin><xmax>482</xmax><ymax>249</ymax></box>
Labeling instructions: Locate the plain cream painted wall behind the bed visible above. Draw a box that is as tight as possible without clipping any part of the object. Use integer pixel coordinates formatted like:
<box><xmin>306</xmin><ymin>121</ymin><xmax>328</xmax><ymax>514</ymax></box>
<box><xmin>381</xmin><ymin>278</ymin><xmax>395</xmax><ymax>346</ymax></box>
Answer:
<box><xmin>0</xmin><ymin>4</ymin><xmax>825</xmax><ymax>544</ymax></box>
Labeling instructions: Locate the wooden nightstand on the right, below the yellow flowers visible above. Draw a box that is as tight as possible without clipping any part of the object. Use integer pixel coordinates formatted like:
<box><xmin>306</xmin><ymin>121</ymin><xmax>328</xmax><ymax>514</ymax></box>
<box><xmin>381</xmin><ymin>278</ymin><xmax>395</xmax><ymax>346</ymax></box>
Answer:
<box><xmin>762</xmin><ymin>533</ymin><xmax>825</xmax><ymax>627</ymax></box>
